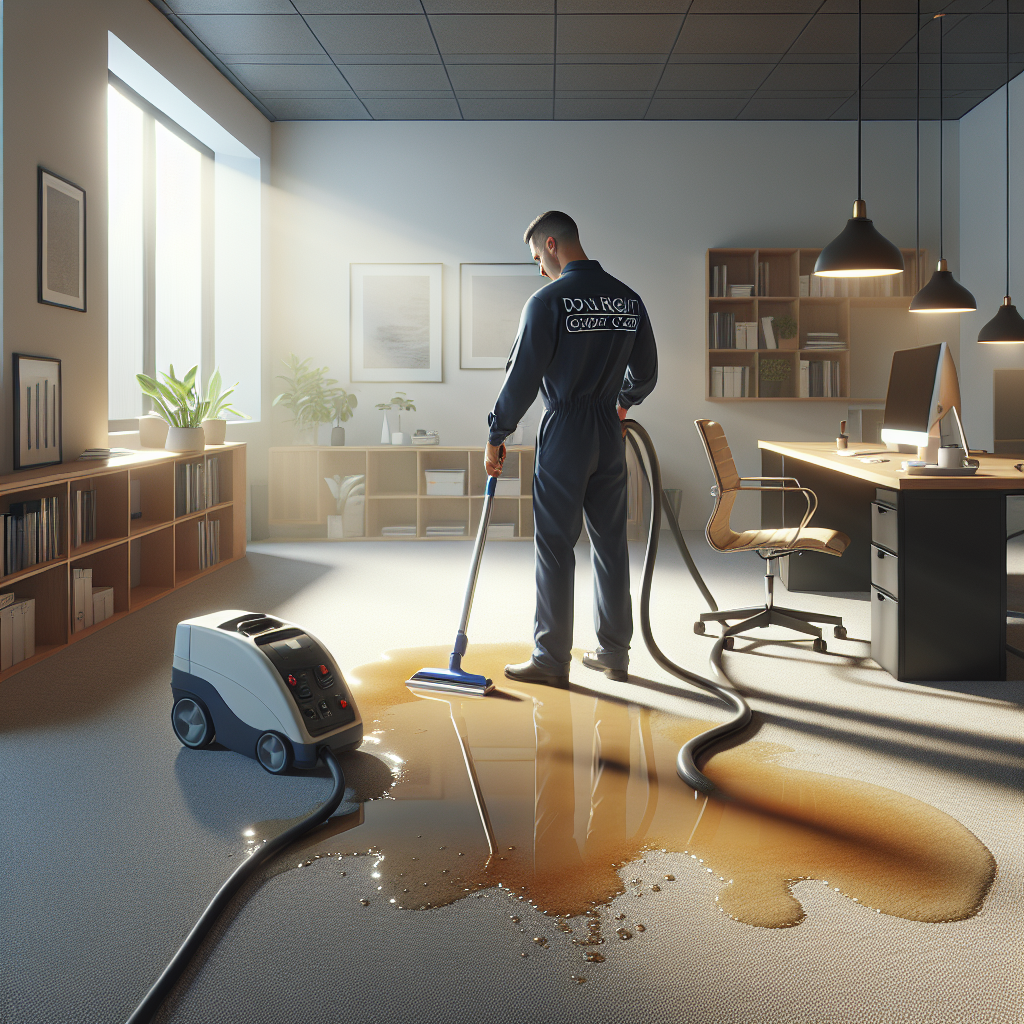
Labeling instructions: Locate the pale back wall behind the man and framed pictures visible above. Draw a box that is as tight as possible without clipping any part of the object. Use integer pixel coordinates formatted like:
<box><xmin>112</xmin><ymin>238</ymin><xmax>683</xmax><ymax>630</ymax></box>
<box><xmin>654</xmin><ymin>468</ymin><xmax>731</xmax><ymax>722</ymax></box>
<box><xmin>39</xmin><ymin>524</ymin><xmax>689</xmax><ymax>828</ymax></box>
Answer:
<box><xmin>268</xmin><ymin>122</ymin><xmax>958</xmax><ymax>526</ymax></box>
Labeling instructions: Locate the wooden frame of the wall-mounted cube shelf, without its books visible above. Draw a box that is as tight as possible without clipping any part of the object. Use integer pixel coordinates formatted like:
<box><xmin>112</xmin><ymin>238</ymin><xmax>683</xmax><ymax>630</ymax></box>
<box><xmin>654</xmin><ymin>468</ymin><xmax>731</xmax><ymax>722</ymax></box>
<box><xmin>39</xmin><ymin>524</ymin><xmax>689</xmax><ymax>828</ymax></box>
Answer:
<box><xmin>705</xmin><ymin>249</ymin><xmax>928</xmax><ymax>402</ymax></box>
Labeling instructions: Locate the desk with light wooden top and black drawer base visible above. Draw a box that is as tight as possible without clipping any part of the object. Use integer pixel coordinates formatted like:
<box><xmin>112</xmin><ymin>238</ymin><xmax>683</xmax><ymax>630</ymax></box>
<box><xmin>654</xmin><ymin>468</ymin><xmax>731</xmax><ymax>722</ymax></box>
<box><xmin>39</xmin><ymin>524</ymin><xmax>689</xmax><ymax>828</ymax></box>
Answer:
<box><xmin>758</xmin><ymin>441</ymin><xmax>1024</xmax><ymax>682</ymax></box>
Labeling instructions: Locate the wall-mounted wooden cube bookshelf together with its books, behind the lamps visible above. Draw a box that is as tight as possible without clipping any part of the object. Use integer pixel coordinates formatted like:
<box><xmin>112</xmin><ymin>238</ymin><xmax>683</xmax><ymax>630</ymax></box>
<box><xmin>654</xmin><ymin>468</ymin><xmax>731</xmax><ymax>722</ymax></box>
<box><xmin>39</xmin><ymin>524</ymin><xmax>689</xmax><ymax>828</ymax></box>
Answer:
<box><xmin>705</xmin><ymin>249</ymin><xmax>927</xmax><ymax>401</ymax></box>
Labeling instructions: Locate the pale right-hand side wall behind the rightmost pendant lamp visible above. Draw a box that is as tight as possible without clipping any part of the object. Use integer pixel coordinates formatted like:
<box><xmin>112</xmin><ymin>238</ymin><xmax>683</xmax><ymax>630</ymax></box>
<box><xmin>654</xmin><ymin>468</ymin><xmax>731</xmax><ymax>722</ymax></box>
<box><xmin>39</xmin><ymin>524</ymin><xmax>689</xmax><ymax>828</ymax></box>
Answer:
<box><xmin>958</xmin><ymin>77</ymin><xmax>1024</xmax><ymax>450</ymax></box>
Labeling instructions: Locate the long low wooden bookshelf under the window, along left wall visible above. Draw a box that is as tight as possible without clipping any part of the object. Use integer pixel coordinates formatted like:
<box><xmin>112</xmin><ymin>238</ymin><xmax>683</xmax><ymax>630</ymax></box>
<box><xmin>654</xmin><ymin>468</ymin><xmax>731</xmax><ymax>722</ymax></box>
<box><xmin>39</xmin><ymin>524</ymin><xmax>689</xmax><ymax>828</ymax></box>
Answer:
<box><xmin>0</xmin><ymin>443</ymin><xmax>246</xmax><ymax>682</ymax></box>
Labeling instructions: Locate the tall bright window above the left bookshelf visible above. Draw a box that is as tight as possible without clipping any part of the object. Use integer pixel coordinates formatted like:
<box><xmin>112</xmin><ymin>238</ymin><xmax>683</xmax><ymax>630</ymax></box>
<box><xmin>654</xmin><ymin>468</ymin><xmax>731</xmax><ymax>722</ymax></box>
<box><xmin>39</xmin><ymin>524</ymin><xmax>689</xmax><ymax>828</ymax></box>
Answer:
<box><xmin>108</xmin><ymin>75</ymin><xmax>216</xmax><ymax>430</ymax></box>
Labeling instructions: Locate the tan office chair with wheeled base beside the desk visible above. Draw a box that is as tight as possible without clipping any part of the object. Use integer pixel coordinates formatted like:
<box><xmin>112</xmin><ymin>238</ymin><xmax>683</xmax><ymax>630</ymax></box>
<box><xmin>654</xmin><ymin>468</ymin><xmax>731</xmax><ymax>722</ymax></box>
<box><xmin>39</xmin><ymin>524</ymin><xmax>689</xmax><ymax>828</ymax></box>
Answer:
<box><xmin>693</xmin><ymin>420</ymin><xmax>850</xmax><ymax>651</ymax></box>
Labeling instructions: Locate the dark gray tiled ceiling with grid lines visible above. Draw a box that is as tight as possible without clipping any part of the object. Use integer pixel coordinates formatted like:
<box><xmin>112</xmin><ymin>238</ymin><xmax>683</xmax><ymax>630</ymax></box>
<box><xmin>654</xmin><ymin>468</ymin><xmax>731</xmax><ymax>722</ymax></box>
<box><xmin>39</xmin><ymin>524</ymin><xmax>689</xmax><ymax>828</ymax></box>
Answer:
<box><xmin>151</xmin><ymin>0</ymin><xmax>1024</xmax><ymax>121</ymax></box>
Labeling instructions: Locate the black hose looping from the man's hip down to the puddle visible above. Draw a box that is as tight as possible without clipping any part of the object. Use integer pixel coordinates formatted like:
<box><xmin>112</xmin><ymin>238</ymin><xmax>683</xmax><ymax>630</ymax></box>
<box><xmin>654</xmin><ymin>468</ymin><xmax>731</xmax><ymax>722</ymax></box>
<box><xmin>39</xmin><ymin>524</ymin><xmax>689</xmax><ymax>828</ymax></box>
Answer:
<box><xmin>623</xmin><ymin>420</ymin><xmax>751</xmax><ymax>794</ymax></box>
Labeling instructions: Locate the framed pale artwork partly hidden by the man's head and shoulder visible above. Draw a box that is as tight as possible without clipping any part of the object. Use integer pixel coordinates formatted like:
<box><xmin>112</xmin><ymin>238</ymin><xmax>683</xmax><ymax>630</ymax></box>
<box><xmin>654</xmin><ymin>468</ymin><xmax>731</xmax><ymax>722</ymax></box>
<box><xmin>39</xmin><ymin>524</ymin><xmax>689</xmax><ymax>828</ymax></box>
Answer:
<box><xmin>459</xmin><ymin>263</ymin><xmax>548</xmax><ymax>370</ymax></box>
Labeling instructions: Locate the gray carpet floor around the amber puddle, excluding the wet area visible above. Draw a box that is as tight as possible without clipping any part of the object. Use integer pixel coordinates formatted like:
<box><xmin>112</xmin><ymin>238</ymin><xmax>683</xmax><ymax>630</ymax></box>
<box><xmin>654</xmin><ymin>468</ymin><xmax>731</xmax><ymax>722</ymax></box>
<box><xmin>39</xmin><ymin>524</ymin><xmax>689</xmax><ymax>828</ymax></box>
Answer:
<box><xmin>0</xmin><ymin>535</ymin><xmax>1024</xmax><ymax>1024</ymax></box>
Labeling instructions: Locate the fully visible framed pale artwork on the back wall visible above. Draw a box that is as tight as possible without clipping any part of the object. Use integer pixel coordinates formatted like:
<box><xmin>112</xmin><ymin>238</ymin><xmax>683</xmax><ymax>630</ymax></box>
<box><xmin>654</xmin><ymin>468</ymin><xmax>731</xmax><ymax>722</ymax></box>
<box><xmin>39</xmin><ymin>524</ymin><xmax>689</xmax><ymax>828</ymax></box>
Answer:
<box><xmin>350</xmin><ymin>263</ymin><xmax>441</xmax><ymax>382</ymax></box>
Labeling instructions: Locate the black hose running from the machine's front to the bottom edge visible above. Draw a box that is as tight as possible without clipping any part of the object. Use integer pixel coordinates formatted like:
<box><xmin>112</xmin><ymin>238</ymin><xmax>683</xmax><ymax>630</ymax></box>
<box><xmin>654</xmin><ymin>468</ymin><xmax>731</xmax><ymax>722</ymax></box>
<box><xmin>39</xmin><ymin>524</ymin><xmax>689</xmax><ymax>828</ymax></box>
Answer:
<box><xmin>128</xmin><ymin>746</ymin><xmax>345</xmax><ymax>1024</ymax></box>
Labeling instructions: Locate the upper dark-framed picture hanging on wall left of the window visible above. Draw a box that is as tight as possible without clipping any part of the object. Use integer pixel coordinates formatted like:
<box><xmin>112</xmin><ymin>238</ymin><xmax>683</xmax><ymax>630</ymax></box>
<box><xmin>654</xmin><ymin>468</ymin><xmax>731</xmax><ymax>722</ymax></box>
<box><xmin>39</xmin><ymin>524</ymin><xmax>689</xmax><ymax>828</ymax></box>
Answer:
<box><xmin>39</xmin><ymin>167</ymin><xmax>85</xmax><ymax>312</ymax></box>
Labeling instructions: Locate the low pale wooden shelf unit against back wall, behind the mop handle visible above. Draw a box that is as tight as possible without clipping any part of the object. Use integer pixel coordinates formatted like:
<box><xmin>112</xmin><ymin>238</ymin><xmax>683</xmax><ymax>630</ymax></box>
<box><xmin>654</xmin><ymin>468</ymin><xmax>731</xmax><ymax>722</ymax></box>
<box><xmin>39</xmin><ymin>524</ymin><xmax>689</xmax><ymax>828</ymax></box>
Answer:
<box><xmin>269</xmin><ymin>445</ymin><xmax>534</xmax><ymax>540</ymax></box>
